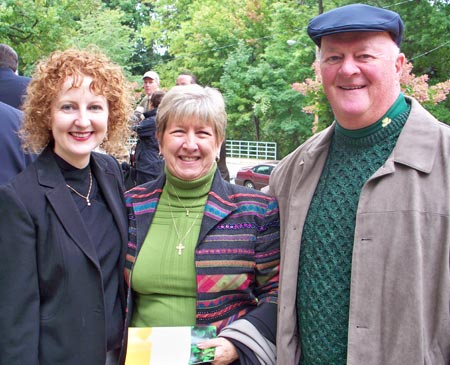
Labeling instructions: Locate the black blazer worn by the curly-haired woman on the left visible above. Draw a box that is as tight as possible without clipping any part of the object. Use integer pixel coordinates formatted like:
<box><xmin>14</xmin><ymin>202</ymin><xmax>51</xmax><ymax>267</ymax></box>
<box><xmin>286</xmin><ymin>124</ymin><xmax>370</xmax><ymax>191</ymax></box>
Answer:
<box><xmin>0</xmin><ymin>147</ymin><xmax>127</xmax><ymax>365</ymax></box>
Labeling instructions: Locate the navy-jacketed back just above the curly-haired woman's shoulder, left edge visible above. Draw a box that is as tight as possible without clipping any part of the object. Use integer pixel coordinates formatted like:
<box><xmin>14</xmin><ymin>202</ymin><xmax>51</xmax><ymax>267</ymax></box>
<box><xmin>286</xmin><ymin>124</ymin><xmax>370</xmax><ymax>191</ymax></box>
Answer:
<box><xmin>0</xmin><ymin>101</ymin><xmax>35</xmax><ymax>185</ymax></box>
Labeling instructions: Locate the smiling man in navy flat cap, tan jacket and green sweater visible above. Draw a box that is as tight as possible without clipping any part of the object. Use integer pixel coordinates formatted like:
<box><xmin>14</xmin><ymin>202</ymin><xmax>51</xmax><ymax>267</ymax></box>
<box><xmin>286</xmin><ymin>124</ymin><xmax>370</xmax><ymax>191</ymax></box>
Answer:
<box><xmin>269</xmin><ymin>4</ymin><xmax>450</xmax><ymax>365</ymax></box>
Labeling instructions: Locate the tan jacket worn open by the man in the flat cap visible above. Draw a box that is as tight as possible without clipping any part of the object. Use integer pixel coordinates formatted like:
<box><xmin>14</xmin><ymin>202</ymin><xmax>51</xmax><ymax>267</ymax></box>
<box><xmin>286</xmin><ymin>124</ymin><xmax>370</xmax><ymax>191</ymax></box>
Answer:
<box><xmin>270</xmin><ymin>98</ymin><xmax>450</xmax><ymax>365</ymax></box>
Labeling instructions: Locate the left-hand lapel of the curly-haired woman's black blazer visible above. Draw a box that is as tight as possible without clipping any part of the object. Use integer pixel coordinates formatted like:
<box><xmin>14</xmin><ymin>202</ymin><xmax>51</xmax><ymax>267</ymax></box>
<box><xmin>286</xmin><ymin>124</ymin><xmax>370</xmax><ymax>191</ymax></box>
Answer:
<box><xmin>36</xmin><ymin>146</ymin><xmax>100</xmax><ymax>269</ymax></box>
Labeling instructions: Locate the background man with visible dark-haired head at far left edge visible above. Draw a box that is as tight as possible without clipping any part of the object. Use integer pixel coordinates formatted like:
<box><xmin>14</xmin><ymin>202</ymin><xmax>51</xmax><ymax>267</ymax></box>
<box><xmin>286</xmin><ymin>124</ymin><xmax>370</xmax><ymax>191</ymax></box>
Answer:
<box><xmin>0</xmin><ymin>44</ymin><xmax>31</xmax><ymax>109</ymax></box>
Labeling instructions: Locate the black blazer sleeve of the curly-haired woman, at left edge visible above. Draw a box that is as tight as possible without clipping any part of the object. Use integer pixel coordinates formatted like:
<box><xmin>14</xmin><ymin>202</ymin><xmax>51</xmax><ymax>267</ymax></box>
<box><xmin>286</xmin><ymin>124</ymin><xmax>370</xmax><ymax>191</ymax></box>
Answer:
<box><xmin>0</xmin><ymin>185</ymin><xmax>40</xmax><ymax>365</ymax></box>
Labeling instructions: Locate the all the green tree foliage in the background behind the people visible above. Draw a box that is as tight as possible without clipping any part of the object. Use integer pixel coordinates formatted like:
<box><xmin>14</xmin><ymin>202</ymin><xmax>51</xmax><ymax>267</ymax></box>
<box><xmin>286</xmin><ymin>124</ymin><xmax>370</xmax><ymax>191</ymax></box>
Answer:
<box><xmin>0</xmin><ymin>0</ymin><xmax>450</xmax><ymax>158</ymax></box>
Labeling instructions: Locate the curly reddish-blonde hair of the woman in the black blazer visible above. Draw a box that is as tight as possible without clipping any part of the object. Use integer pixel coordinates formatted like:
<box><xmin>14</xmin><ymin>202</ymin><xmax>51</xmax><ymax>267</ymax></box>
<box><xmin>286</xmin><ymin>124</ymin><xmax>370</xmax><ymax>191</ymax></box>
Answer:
<box><xmin>20</xmin><ymin>49</ymin><xmax>133</xmax><ymax>156</ymax></box>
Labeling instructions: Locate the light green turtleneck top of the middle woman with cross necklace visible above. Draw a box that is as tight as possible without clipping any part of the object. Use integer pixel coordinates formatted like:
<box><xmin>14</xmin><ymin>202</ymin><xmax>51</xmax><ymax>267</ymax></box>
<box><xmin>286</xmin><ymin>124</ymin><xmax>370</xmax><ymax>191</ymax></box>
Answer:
<box><xmin>131</xmin><ymin>165</ymin><xmax>217</xmax><ymax>327</ymax></box>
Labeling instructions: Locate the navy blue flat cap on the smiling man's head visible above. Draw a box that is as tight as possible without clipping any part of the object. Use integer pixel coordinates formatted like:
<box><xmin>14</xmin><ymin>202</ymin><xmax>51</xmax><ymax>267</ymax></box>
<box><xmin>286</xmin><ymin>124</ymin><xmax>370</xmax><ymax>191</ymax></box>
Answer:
<box><xmin>307</xmin><ymin>4</ymin><xmax>404</xmax><ymax>47</ymax></box>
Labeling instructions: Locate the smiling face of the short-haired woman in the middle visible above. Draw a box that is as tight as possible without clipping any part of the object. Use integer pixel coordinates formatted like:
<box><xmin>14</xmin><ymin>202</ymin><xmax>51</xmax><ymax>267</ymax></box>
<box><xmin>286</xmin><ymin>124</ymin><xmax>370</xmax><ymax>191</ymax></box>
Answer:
<box><xmin>160</xmin><ymin>118</ymin><xmax>222</xmax><ymax>181</ymax></box>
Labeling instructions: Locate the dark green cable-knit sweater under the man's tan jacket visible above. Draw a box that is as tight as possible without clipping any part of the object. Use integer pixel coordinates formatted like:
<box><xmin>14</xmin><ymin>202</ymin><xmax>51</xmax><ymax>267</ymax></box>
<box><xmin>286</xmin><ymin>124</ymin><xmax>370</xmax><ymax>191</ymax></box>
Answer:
<box><xmin>297</xmin><ymin>95</ymin><xmax>410</xmax><ymax>365</ymax></box>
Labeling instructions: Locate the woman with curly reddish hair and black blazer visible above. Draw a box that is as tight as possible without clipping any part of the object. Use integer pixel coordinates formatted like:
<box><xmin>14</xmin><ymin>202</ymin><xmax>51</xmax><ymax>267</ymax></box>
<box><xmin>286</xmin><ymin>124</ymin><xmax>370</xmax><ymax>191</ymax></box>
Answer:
<box><xmin>0</xmin><ymin>49</ymin><xmax>131</xmax><ymax>365</ymax></box>
